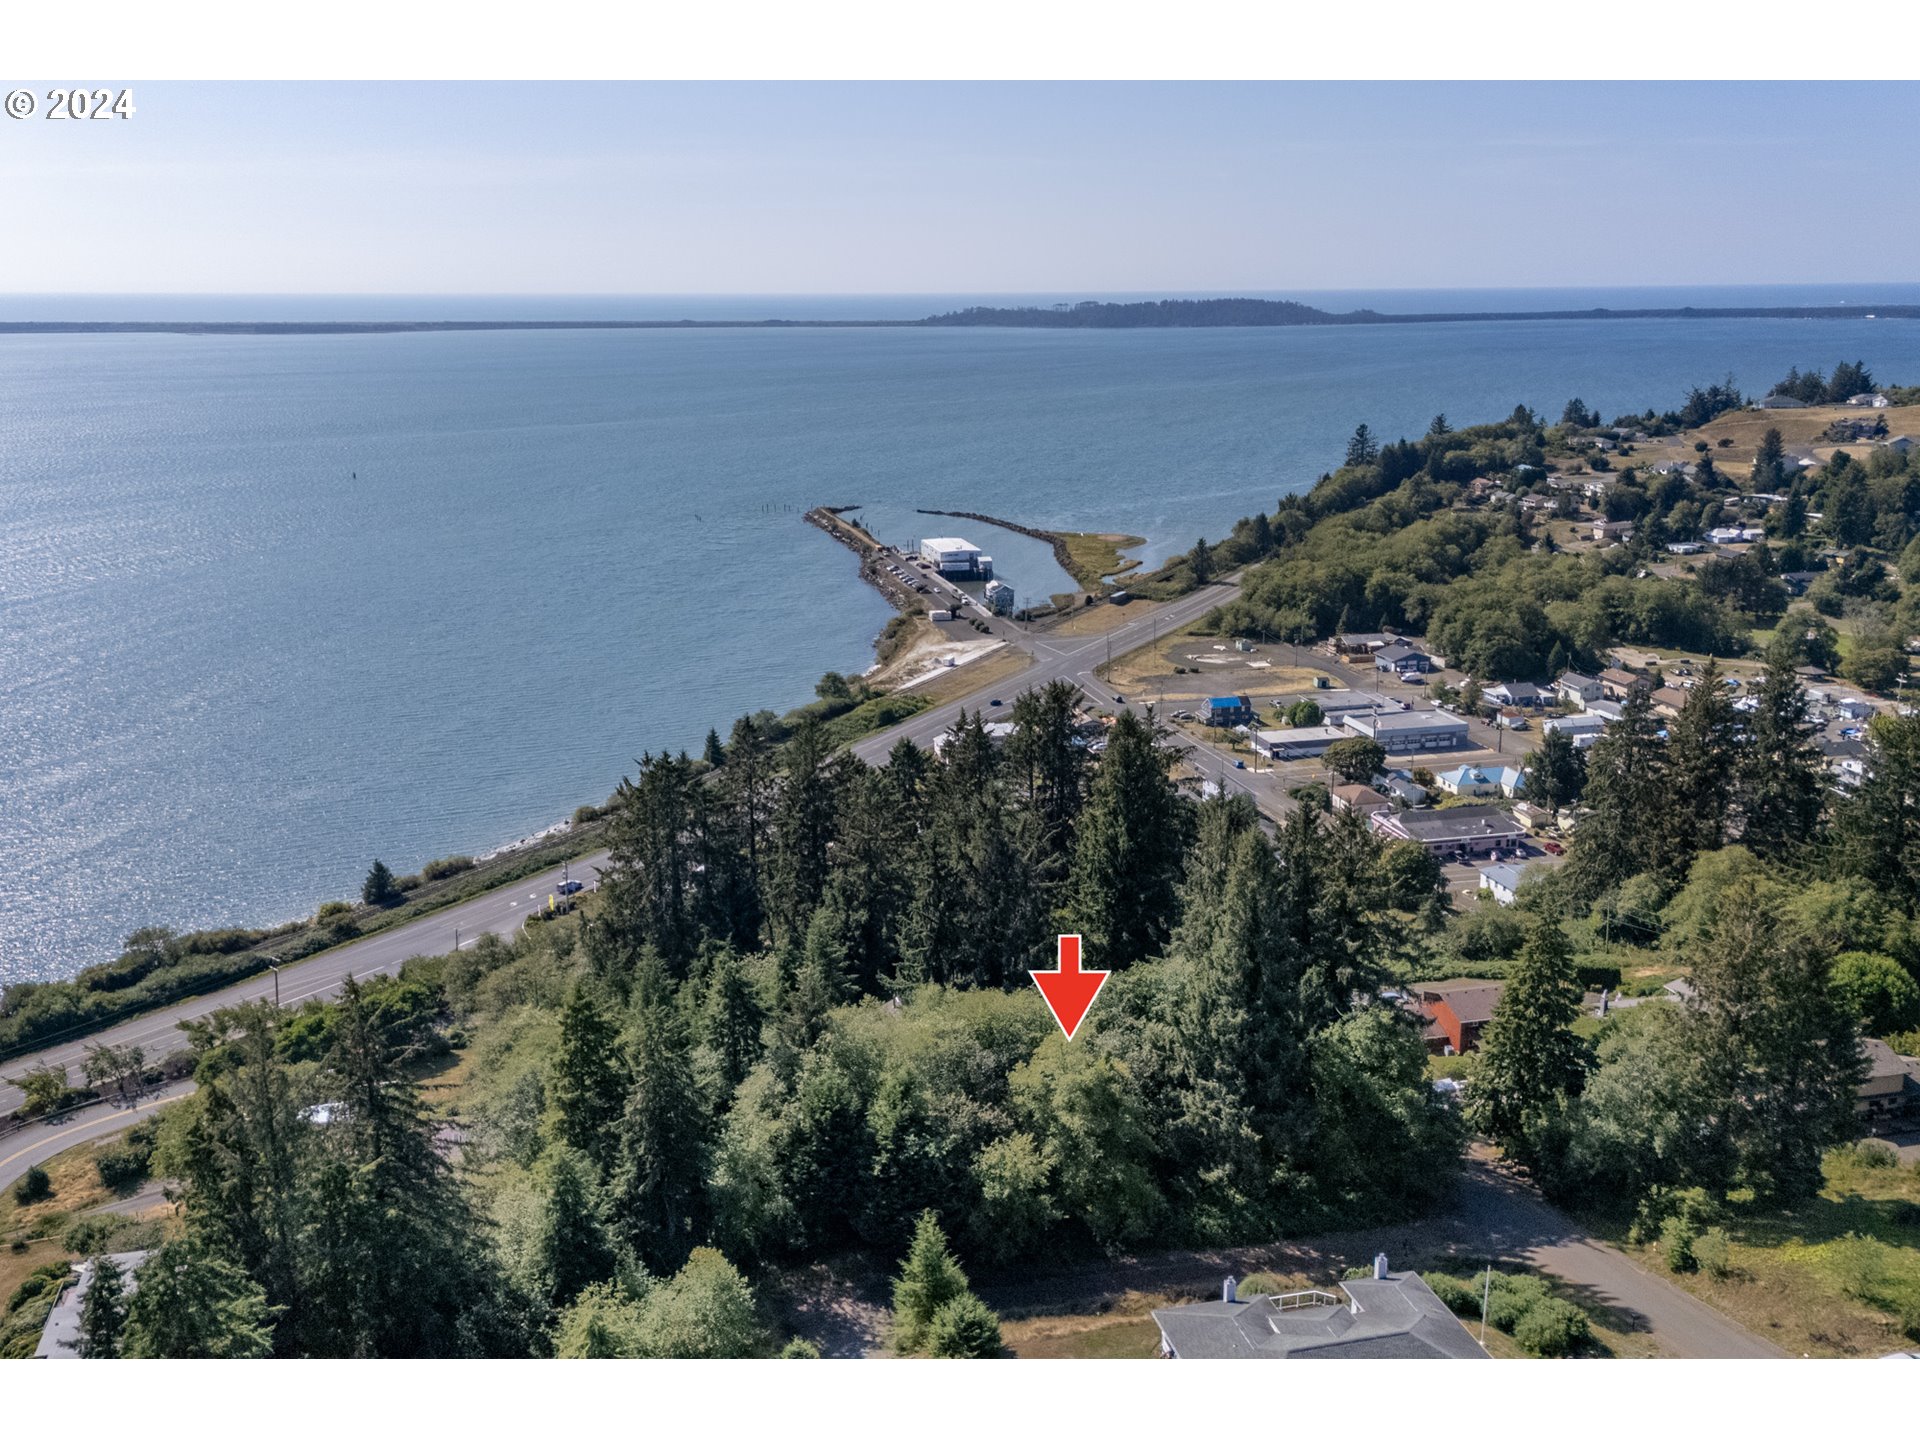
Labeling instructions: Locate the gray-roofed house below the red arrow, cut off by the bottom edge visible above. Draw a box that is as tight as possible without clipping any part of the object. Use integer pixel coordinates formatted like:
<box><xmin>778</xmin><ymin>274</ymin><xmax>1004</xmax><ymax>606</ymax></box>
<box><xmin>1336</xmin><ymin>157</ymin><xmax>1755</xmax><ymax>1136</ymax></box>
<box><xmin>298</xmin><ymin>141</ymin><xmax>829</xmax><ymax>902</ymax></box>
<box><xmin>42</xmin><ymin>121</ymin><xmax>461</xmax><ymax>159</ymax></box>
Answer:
<box><xmin>1154</xmin><ymin>1256</ymin><xmax>1488</xmax><ymax>1359</ymax></box>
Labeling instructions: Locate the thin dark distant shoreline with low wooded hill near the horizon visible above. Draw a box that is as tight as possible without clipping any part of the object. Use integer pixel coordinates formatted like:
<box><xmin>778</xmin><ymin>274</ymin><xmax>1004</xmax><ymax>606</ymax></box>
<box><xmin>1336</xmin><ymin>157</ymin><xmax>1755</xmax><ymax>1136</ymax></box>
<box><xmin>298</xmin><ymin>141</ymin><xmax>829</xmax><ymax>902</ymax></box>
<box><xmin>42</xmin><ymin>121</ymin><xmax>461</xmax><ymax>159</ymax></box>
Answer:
<box><xmin>0</xmin><ymin>300</ymin><xmax>1920</xmax><ymax>336</ymax></box>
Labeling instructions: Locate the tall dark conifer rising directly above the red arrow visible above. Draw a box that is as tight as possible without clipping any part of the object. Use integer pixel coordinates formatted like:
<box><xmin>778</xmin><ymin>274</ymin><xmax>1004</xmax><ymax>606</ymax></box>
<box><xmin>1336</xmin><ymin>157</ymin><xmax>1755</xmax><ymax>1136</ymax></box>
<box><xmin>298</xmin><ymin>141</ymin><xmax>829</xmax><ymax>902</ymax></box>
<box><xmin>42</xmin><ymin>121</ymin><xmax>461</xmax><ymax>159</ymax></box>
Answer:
<box><xmin>1066</xmin><ymin>710</ymin><xmax>1188</xmax><ymax>970</ymax></box>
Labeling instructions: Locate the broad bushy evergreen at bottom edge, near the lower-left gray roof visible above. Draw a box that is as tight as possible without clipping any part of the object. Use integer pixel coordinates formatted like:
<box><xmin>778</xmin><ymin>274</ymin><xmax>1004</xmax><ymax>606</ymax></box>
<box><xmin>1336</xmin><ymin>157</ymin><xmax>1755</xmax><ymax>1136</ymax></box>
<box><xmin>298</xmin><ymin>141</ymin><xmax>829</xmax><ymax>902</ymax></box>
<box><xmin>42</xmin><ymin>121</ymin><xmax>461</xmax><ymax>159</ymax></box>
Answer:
<box><xmin>121</xmin><ymin>1240</ymin><xmax>275</xmax><ymax>1359</ymax></box>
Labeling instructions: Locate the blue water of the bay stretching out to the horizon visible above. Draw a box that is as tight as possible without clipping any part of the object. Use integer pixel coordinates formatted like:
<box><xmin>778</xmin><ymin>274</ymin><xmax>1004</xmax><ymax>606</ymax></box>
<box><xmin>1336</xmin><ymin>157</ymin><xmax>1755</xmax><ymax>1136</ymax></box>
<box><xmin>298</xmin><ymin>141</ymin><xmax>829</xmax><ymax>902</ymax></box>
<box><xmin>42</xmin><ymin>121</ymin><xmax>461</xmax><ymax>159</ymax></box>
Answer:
<box><xmin>0</xmin><ymin>299</ymin><xmax>1920</xmax><ymax>979</ymax></box>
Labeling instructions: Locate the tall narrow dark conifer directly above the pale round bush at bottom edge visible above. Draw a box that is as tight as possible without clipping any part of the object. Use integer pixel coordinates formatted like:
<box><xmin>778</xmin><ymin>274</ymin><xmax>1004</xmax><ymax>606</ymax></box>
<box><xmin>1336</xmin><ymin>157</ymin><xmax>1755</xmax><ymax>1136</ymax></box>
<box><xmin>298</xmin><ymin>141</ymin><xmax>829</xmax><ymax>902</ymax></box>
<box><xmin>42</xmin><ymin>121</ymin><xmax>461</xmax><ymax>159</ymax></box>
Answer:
<box><xmin>611</xmin><ymin>1006</ymin><xmax>707</xmax><ymax>1273</ymax></box>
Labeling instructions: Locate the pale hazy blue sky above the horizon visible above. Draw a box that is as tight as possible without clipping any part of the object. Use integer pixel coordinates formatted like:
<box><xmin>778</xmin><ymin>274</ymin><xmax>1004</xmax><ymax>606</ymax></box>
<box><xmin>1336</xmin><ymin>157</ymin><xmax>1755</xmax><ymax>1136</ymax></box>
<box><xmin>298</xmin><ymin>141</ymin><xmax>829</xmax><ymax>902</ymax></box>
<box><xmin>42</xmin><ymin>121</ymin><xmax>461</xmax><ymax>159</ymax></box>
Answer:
<box><xmin>0</xmin><ymin>81</ymin><xmax>1920</xmax><ymax>294</ymax></box>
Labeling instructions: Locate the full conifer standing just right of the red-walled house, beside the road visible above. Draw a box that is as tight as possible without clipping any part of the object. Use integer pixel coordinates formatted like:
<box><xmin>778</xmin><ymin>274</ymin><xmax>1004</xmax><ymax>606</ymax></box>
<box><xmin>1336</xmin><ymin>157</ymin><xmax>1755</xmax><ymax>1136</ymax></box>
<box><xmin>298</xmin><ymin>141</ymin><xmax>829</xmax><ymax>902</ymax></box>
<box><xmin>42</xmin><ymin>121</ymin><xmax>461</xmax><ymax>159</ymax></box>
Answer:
<box><xmin>1467</xmin><ymin>920</ymin><xmax>1588</xmax><ymax>1160</ymax></box>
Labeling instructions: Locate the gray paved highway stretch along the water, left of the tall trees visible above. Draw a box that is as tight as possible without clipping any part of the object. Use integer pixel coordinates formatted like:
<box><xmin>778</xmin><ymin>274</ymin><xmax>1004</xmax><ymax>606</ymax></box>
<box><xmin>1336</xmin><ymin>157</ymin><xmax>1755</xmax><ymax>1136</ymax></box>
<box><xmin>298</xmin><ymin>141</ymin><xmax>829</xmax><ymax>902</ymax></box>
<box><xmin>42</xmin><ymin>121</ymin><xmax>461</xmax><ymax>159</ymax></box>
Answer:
<box><xmin>0</xmin><ymin>851</ymin><xmax>607</xmax><ymax>1116</ymax></box>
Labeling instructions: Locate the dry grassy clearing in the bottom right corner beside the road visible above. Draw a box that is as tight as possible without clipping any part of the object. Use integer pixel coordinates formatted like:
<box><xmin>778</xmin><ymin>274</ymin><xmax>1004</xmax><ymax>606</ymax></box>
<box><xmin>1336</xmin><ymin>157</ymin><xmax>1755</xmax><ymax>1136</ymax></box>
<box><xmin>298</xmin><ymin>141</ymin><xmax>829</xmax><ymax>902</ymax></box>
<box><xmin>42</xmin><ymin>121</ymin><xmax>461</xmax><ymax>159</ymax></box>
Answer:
<box><xmin>1628</xmin><ymin>1150</ymin><xmax>1920</xmax><ymax>1356</ymax></box>
